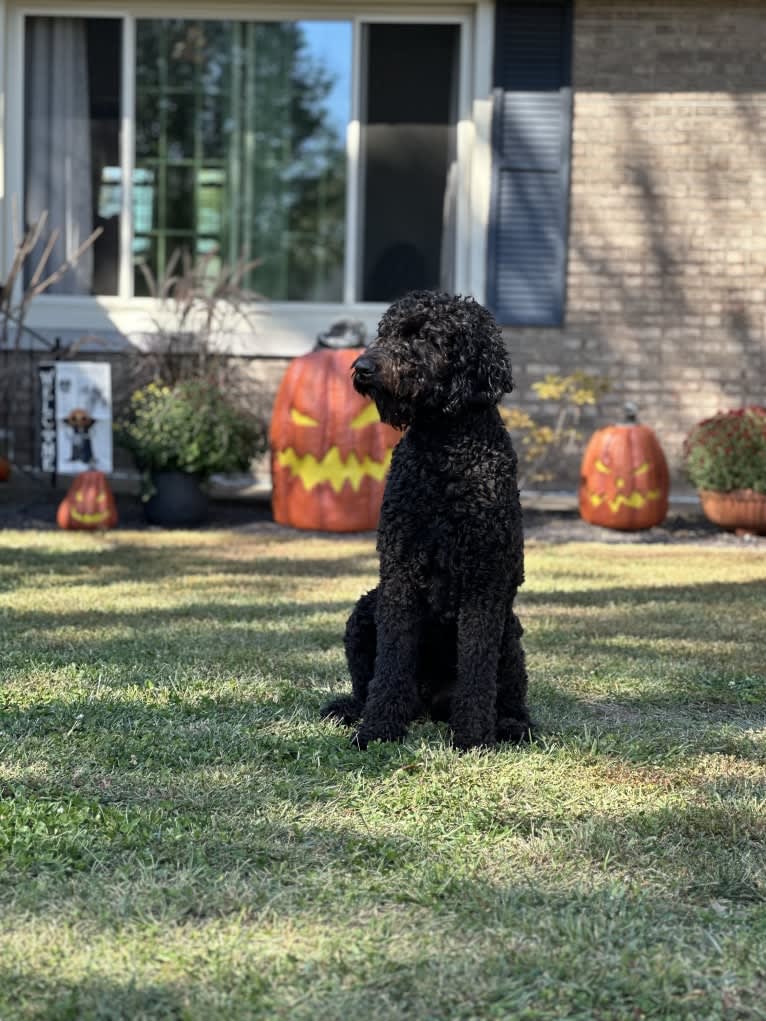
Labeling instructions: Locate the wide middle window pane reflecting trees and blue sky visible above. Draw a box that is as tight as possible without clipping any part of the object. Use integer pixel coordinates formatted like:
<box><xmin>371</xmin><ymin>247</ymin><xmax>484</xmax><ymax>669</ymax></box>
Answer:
<box><xmin>134</xmin><ymin>19</ymin><xmax>351</xmax><ymax>301</ymax></box>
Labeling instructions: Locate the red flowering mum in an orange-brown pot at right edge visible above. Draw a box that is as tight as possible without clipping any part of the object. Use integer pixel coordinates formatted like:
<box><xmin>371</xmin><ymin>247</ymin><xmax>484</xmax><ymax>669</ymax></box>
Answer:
<box><xmin>683</xmin><ymin>406</ymin><xmax>766</xmax><ymax>535</ymax></box>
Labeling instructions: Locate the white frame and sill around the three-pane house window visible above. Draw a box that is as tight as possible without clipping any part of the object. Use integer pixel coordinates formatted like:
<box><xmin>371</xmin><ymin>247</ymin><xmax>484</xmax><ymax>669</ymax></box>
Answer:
<box><xmin>0</xmin><ymin>0</ymin><xmax>494</xmax><ymax>355</ymax></box>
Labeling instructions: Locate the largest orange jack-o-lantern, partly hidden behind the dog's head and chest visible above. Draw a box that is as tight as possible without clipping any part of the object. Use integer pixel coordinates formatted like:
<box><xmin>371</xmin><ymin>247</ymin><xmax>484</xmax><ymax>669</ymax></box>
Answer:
<box><xmin>270</xmin><ymin>348</ymin><xmax>399</xmax><ymax>532</ymax></box>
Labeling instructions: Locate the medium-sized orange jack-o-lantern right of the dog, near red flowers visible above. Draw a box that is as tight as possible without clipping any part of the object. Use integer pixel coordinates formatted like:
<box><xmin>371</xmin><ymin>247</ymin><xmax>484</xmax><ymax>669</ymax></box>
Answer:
<box><xmin>579</xmin><ymin>410</ymin><xmax>670</xmax><ymax>532</ymax></box>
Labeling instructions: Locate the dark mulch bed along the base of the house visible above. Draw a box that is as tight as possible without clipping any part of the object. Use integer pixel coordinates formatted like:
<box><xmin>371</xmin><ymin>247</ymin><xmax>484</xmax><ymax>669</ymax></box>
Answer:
<box><xmin>0</xmin><ymin>484</ymin><xmax>766</xmax><ymax>550</ymax></box>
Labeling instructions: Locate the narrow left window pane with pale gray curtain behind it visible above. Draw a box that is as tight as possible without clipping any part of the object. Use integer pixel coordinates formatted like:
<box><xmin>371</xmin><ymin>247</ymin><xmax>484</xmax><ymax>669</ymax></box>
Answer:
<box><xmin>25</xmin><ymin>17</ymin><xmax>122</xmax><ymax>294</ymax></box>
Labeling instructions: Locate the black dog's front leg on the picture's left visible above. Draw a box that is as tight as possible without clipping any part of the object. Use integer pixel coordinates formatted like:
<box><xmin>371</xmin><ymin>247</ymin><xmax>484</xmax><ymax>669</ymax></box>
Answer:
<box><xmin>352</xmin><ymin>582</ymin><xmax>421</xmax><ymax>748</ymax></box>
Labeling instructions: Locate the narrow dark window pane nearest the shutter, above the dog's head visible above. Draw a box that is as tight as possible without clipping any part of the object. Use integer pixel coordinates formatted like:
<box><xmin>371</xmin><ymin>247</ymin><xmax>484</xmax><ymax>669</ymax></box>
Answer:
<box><xmin>362</xmin><ymin>25</ymin><xmax>460</xmax><ymax>301</ymax></box>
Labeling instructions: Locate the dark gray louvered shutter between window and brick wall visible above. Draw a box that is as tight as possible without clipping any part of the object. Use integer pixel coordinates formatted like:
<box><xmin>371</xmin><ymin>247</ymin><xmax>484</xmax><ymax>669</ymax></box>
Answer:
<box><xmin>487</xmin><ymin>0</ymin><xmax>572</xmax><ymax>326</ymax></box>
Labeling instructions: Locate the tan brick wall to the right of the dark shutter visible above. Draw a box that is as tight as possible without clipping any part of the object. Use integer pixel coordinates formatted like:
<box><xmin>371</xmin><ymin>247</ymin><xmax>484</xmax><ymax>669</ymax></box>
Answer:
<box><xmin>507</xmin><ymin>0</ymin><xmax>766</xmax><ymax>488</ymax></box>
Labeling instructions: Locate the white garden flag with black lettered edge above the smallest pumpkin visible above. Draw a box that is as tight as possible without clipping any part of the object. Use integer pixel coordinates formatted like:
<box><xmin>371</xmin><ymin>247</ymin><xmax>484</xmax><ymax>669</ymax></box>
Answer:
<box><xmin>40</xmin><ymin>361</ymin><xmax>112</xmax><ymax>475</ymax></box>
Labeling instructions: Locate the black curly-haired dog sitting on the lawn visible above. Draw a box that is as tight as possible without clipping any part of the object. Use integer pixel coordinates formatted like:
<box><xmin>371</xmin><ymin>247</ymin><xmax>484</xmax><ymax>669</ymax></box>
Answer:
<box><xmin>323</xmin><ymin>291</ymin><xmax>530</xmax><ymax>748</ymax></box>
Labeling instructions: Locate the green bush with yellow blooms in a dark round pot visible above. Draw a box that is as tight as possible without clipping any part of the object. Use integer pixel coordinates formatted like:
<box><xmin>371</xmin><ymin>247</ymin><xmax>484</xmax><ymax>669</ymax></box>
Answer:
<box><xmin>116</xmin><ymin>379</ymin><xmax>267</xmax><ymax>526</ymax></box>
